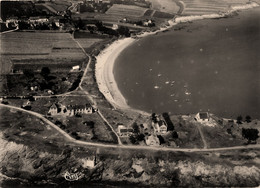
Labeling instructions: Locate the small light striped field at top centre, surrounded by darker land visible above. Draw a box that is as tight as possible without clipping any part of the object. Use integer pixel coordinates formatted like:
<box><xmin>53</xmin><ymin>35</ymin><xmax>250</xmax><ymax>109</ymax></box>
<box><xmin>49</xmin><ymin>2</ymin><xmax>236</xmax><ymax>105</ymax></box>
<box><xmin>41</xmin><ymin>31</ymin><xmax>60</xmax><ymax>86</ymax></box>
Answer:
<box><xmin>106</xmin><ymin>4</ymin><xmax>147</xmax><ymax>17</ymax></box>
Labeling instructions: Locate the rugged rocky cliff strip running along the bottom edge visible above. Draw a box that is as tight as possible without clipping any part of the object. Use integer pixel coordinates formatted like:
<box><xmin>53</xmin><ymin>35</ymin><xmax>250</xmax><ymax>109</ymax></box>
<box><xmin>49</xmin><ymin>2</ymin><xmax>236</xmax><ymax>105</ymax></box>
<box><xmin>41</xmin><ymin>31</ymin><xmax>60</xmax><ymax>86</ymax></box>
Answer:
<box><xmin>0</xmin><ymin>132</ymin><xmax>260</xmax><ymax>187</ymax></box>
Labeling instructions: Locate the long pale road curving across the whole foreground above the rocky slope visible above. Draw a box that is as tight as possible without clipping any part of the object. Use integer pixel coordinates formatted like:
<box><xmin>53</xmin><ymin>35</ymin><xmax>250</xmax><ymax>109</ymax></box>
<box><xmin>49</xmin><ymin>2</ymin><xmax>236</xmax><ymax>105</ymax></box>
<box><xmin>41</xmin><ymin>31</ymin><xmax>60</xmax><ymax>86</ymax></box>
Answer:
<box><xmin>0</xmin><ymin>104</ymin><xmax>260</xmax><ymax>152</ymax></box>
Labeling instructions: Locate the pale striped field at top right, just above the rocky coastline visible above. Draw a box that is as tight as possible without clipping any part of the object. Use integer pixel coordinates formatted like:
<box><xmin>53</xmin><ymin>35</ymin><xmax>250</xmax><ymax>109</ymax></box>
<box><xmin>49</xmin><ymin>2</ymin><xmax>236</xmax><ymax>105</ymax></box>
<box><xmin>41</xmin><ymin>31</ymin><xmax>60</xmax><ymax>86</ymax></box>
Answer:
<box><xmin>183</xmin><ymin>0</ymin><xmax>248</xmax><ymax>15</ymax></box>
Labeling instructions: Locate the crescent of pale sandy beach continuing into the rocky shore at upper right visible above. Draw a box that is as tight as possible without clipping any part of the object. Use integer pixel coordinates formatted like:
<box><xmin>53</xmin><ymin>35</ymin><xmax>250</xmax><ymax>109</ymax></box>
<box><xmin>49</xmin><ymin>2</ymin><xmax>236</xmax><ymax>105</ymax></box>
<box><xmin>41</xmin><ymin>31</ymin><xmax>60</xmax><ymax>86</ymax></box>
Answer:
<box><xmin>95</xmin><ymin>2</ymin><xmax>259</xmax><ymax>115</ymax></box>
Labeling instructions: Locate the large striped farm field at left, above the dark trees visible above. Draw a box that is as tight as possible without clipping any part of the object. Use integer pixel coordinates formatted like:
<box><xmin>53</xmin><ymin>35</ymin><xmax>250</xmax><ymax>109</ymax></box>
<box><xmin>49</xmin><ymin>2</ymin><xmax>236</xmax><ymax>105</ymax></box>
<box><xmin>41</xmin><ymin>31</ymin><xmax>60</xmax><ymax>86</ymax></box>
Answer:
<box><xmin>0</xmin><ymin>32</ymin><xmax>85</xmax><ymax>74</ymax></box>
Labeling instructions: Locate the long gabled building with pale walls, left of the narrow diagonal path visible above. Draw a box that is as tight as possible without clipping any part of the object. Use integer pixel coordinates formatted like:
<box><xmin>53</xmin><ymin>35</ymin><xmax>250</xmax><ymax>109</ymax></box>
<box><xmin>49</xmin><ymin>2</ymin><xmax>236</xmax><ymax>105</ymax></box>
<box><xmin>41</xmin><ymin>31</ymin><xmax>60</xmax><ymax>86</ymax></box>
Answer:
<box><xmin>48</xmin><ymin>103</ymin><xmax>96</xmax><ymax>116</ymax></box>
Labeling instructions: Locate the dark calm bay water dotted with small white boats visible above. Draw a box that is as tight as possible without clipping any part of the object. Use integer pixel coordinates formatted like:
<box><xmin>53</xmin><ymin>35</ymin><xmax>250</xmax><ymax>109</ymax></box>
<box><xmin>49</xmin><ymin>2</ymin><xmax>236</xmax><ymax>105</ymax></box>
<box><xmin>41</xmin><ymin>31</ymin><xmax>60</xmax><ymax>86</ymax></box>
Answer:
<box><xmin>114</xmin><ymin>8</ymin><xmax>260</xmax><ymax>118</ymax></box>
